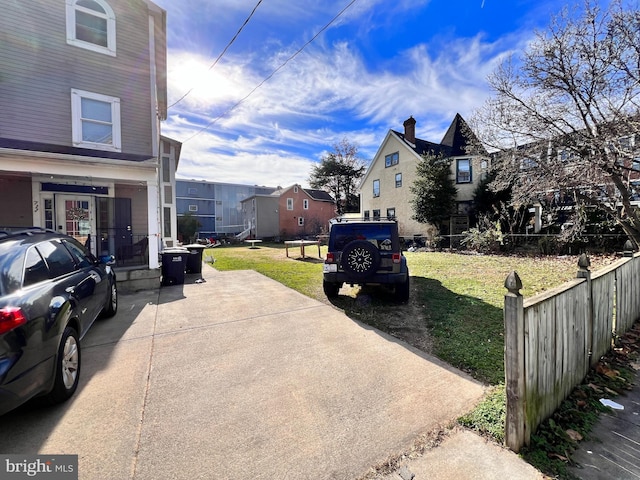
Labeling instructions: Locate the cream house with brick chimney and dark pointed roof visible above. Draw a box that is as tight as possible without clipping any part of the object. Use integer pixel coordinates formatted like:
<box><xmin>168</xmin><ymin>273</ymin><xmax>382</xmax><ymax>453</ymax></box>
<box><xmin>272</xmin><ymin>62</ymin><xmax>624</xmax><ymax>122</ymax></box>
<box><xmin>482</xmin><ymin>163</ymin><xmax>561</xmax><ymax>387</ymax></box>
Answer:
<box><xmin>360</xmin><ymin>114</ymin><xmax>489</xmax><ymax>237</ymax></box>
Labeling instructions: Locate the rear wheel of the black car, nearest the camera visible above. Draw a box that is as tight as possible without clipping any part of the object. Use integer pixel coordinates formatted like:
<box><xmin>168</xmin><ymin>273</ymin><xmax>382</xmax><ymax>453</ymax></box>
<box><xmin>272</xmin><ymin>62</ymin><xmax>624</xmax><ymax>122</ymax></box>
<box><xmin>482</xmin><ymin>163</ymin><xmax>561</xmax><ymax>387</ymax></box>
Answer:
<box><xmin>46</xmin><ymin>327</ymin><xmax>80</xmax><ymax>403</ymax></box>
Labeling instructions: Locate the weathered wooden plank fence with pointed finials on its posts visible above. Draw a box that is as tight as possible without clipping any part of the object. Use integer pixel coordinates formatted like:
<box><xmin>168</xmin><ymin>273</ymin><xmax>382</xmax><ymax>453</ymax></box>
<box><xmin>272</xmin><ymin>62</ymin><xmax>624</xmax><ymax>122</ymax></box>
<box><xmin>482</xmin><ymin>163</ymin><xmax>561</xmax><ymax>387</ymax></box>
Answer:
<box><xmin>504</xmin><ymin>252</ymin><xmax>640</xmax><ymax>452</ymax></box>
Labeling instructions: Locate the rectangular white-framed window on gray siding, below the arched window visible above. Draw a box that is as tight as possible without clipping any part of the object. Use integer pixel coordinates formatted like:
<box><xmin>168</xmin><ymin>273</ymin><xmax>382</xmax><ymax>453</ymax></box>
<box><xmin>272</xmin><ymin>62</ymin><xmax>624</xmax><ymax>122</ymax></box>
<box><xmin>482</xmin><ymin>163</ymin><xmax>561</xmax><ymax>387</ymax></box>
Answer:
<box><xmin>71</xmin><ymin>89</ymin><xmax>122</xmax><ymax>152</ymax></box>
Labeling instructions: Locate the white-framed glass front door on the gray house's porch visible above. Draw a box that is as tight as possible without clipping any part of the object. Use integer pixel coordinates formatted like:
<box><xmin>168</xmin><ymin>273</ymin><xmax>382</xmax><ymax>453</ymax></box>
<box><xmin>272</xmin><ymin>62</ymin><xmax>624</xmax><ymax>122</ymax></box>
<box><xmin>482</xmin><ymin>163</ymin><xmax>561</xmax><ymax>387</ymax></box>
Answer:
<box><xmin>56</xmin><ymin>195</ymin><xmax>96</xmax><ymax>254</ymax></box>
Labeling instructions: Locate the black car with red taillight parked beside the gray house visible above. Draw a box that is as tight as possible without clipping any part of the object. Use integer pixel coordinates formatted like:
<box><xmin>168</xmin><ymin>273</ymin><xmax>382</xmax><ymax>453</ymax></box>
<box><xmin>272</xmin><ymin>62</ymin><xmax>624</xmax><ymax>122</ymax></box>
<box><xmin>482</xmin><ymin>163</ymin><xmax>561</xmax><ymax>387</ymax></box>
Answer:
<box><xmin>0</xmin><ymin>228</ymin><xmax>118</xmax><ymax>415</ymax></box>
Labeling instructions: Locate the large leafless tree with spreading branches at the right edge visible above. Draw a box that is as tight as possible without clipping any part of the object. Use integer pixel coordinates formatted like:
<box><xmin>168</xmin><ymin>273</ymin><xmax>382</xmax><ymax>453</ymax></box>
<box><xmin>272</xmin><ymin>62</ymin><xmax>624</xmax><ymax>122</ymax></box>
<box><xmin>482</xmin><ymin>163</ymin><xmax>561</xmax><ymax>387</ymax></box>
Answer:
<box><xmin>472</xmin><ymin>0</ymin><xmax>640</xmax><ymax>246</ymax></box>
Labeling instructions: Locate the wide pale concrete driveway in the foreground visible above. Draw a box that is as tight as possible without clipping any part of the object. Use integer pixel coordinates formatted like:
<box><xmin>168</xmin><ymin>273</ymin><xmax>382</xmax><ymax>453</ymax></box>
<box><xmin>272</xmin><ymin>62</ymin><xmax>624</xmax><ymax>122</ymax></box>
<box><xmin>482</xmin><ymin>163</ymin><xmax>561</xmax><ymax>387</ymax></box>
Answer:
<box><xmin>0</xmin><ymin>265</ymin><xmax>483</xmax><ymax>480</ymax></box>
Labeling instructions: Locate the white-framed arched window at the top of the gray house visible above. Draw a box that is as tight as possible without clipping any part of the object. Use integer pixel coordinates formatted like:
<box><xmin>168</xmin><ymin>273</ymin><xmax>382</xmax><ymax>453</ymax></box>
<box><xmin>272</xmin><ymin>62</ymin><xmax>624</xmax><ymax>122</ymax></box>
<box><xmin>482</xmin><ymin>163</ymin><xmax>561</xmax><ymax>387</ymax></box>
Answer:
<box><xmin>67</xmin><ymin>0</ymin><xmax>116</xmax><ymax>56</ymax></box>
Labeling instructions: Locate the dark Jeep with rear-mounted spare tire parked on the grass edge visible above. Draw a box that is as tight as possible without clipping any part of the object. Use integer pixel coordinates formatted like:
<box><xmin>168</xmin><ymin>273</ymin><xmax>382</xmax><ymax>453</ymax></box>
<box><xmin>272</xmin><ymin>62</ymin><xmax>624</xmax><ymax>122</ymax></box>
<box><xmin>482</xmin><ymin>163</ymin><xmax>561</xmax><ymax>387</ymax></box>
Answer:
<box><xmin>322</xmin><ymin>218</ymin><xmax>409</xmax><ymax>302</ymax></box>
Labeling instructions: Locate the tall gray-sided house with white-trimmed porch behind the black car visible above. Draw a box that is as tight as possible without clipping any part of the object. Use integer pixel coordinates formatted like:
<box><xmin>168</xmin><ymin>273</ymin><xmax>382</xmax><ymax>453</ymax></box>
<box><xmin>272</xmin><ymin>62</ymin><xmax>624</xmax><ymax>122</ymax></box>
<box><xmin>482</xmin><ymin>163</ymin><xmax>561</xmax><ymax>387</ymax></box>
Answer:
<box><xmin>0</xmin><ymin>0</ymin><xmax>180</xmax><ymax>269</ymax></box>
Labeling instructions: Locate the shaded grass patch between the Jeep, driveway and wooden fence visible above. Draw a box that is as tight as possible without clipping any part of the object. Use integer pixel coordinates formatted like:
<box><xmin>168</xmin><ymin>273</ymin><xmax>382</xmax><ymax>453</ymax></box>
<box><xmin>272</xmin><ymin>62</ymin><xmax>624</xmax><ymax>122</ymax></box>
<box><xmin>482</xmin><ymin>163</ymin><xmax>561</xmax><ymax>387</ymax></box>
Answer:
<box><xmin>330</xmin><ymin>277</ymin><xmax>504</xmax><ymax>385</ymax></box>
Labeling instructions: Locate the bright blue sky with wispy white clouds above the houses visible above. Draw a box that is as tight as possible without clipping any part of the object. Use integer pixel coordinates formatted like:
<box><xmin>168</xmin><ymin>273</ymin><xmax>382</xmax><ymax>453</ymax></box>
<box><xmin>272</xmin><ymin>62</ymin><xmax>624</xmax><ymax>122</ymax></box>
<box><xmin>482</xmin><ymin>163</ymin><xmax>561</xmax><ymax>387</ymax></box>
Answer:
<box><xmin>154</xmin><ymin>0</ymin><xmax>580</xmax><ymax>187</ymax></box>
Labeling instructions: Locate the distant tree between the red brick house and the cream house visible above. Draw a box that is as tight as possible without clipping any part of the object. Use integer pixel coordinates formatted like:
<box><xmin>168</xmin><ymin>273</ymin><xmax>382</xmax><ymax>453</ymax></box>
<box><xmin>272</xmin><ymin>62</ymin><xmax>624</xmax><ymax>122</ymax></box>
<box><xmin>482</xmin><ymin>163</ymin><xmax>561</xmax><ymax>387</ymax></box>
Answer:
<box><xmin>309</xmin><ymin>138</ymin><xmax>366</xmax><ymax>215</ymax></box>
